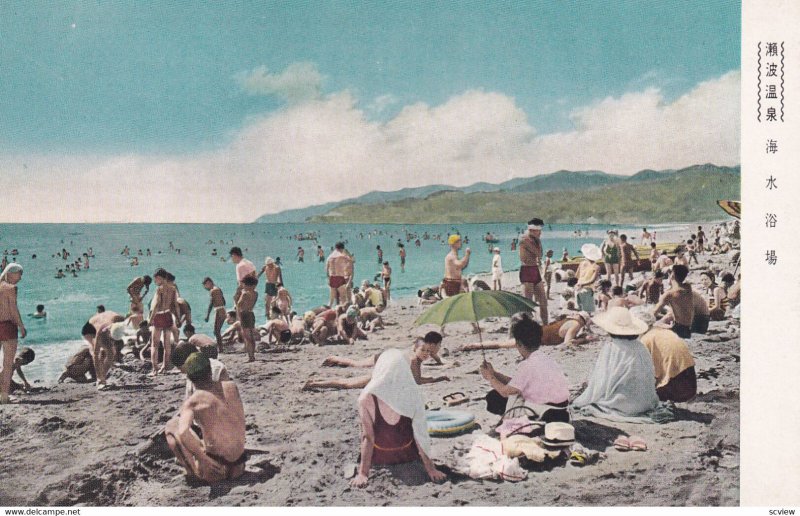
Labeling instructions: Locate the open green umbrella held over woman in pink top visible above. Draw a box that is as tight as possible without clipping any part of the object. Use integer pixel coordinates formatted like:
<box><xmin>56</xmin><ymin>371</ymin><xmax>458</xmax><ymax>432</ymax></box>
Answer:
<box><xmin>414</xmin><ymin>290</ymin><xmax>538</xmax><ymax>360</ymax></box>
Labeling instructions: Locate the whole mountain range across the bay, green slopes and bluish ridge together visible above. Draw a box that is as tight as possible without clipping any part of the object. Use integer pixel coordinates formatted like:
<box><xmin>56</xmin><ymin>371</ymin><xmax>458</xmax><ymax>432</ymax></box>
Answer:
<box><xmin>255</xmin><ymin>164</ymin><xmax>741</xmax><ymax>224</ymax></box>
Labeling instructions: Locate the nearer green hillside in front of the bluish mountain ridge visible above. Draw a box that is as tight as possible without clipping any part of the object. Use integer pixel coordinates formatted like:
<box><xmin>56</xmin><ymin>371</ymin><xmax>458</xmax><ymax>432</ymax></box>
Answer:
<box><xmin>309</xmin><ymin>165</ymin><xmax>740</xmax><ymax>224</ymax></box>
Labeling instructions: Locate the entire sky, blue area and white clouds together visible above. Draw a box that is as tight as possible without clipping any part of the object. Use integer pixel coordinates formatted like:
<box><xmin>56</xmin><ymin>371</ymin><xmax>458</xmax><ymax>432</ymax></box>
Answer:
<box><xmin>0</xmin><ymin>0</ymin><xmax>741</xmax><ymax>222</ymax></box>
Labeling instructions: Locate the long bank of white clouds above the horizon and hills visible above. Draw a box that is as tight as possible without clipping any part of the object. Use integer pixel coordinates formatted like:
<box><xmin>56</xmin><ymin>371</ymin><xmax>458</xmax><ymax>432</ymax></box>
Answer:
<box><xmin>0</xmin><ymin>67</ymin><xmax>740</xmax><ymax>222</ymax></box>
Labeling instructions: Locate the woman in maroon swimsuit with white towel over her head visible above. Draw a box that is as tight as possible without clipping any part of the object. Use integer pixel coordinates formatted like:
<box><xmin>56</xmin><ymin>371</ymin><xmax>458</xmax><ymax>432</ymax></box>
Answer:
<box><xmin>352</xmin><ymin>349</ymin><xmax>445</xmax><ymax>487</ymax></box>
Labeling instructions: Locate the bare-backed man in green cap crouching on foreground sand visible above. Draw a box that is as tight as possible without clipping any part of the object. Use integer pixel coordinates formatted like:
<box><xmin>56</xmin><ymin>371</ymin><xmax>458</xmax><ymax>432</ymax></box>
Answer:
<box><xmin>164</xmin><ymin>353</ymin><xmax>247</xmax><ymax>484</ymax></box>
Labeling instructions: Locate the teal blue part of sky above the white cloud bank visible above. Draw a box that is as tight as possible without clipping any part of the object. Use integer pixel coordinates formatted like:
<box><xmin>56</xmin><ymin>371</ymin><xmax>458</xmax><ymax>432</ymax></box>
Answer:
<box><xmin>0</xmin><ymin>0</ymin><xmax>741</xmax><ymax>222</ymax></box>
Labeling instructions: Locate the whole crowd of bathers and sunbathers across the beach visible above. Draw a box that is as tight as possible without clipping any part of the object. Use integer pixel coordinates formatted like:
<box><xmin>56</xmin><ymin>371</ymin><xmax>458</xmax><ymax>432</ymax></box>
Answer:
<box><xmin>0</xmin><ymin>218</ymin><xmax>741</xmax><ymax>486</ymax></box>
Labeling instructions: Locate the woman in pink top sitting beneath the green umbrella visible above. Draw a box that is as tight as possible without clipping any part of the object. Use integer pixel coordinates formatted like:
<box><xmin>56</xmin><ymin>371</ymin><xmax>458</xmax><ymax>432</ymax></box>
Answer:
<box><xmin>480</xmin><ymin>312</ymin><xmax>569</xmax><ymax>422</ymax></box>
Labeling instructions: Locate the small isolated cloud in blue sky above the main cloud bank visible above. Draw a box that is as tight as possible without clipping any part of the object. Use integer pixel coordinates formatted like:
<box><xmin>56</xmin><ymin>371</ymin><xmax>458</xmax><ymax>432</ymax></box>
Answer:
<box><xmin>235</xmin><ymin>62</ymin><xmax>322</xmax><ymax>103</ymax></box>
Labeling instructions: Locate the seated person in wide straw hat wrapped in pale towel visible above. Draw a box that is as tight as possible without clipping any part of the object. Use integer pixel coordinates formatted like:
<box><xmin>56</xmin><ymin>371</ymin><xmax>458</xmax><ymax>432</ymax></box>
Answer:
<box><xmin>572</xmin><ymin>307</ymin><xmax>669</xmax><ymax>423</ymax></box>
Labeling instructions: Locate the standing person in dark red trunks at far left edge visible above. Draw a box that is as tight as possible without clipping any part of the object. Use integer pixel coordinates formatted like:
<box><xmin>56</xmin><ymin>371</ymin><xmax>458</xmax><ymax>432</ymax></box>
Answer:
<box><xmin>0</xmin><ymin>263</ymin><xmax>26</xmax><ymax>404</ymax></box>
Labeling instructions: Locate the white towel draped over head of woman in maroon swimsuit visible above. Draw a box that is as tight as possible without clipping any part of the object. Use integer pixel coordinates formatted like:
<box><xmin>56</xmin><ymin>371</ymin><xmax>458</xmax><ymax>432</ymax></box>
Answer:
<box><xmin>358</xmin><ymin>349</ymin><xmax>431</xmax><ymax>457</ymax></box>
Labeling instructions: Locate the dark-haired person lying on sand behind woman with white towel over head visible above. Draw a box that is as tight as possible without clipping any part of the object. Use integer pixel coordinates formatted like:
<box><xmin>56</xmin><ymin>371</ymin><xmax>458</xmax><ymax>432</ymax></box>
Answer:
<box><xmin>303</xmin><ymin>331</ymin><xmax>450</xmax><ymax>391</ymax></box>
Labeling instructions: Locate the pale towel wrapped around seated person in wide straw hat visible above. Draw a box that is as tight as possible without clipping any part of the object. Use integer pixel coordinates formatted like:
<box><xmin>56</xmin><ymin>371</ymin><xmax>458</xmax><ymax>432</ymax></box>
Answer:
<box><xmin>572</xmin><ymin>338</ymin><xmax>675</xmax><ymax>423</ymax></box>
